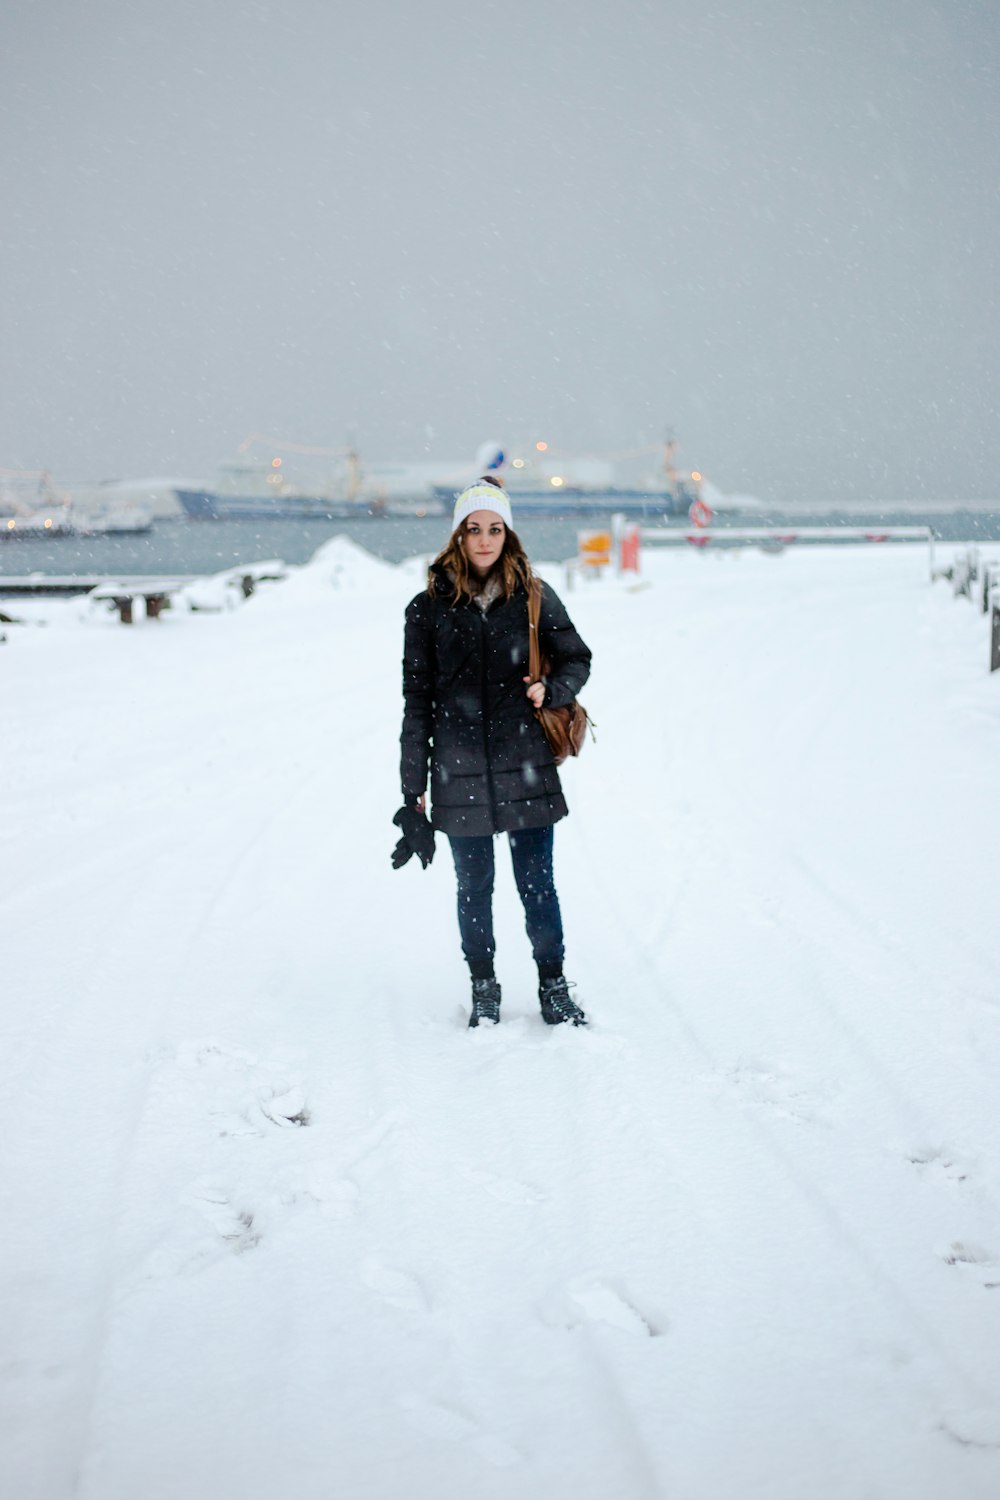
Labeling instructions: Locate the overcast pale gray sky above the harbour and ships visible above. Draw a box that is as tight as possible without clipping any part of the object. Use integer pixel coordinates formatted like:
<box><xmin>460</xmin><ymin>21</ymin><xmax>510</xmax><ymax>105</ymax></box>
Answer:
<box><xmin>0</xmin><ymin>0</ymin><xmax>1000</xmax><ymax>501</ymax></box>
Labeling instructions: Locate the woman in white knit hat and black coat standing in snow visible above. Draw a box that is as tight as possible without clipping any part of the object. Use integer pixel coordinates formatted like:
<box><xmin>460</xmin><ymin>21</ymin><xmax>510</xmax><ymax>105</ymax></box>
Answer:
<box><xmin>393</xmin><ymin>476</ymin><xmax>591</xmax><ymax>1026</ymax></box>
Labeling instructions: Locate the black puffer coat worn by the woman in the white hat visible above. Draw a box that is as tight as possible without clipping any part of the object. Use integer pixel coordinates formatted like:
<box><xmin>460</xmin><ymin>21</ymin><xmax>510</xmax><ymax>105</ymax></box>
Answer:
<box><xmin>400</xmin><ymin>572</ymin><xmax>591</xmax><ymax>836</ymax></box>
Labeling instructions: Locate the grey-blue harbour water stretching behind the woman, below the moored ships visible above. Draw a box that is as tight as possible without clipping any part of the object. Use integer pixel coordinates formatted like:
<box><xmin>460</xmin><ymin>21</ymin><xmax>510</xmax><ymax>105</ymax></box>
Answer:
<box><xmin>0</xmin><ymin>506</ymin><xmax>1000</xmax><ymax>576</ymax></box>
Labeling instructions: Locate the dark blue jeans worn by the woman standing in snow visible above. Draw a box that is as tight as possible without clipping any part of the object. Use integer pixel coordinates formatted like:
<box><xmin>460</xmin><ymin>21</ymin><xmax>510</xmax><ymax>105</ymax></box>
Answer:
<box><xmin>450</xmin><ymin>825</ymin><xmax>564</xmax><ymax>980</ymax></box>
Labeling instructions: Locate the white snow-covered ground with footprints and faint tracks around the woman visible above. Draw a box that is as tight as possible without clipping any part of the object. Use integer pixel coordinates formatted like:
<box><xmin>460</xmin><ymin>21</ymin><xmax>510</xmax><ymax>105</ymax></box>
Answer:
<box><xmin>0</xmin><ymin>542</ymin><xmax>1000</xmax><ymax>1500</ymax></box>
